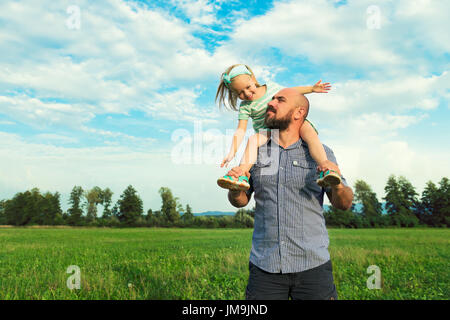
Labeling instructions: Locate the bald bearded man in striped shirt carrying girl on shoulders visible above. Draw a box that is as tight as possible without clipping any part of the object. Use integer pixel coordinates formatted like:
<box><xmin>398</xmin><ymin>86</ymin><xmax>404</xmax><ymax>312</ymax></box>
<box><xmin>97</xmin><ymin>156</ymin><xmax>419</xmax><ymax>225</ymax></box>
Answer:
<box><xmin>228</xmin><ymin>88</ymin><xmax>353</xmax><ymax>300</ymax></box>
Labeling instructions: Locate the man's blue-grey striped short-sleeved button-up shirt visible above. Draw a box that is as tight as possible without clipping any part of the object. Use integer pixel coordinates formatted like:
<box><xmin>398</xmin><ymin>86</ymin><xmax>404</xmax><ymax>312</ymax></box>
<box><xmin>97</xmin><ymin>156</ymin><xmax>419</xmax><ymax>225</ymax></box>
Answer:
<box><xmin>247</xmin><ymin>134</ymin><xmax>347</xmax><ymax>273</ymax></box>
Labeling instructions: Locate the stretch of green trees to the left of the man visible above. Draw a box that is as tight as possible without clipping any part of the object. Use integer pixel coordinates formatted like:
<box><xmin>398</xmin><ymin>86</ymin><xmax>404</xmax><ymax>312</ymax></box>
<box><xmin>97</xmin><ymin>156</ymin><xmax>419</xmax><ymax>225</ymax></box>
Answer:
<box><xmin>0</xmin><ymin>185</ymin><xmax>253</xmax><ymax>228</ymax></box>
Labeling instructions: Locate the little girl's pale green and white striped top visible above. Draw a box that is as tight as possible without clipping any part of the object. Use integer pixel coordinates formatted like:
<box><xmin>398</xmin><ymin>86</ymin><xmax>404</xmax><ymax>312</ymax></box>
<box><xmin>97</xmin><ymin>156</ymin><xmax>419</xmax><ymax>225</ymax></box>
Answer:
<box><xmin>238</xmin><ymin>81</ymin><xmax>283</xmax><ymax>132</ymax></box>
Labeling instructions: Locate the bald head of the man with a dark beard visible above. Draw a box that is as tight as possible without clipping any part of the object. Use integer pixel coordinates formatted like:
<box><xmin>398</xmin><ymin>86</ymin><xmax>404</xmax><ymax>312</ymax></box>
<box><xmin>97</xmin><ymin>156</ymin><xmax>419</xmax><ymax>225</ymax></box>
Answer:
<box><xmin>264</xmin><ymin>88</ymin><xmax>309</xmax><ymax>131</ymax></box>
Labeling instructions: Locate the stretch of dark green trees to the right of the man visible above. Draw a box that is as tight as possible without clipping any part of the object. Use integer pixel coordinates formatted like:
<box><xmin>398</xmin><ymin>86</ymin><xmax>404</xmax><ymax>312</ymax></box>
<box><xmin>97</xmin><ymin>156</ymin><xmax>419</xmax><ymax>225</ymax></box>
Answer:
<box><xmin>324</xmin><ymin>175</ymin><xmax>450</xmax><ymax>228</ymax></box>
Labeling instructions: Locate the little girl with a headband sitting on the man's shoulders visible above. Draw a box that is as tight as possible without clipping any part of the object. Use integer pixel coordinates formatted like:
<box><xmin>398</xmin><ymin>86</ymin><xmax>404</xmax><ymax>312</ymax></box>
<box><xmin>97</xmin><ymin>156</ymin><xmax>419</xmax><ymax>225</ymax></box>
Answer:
<box><xmin>216</xmin><ymin>64</ymin><xmax>341</xmax><ymax>190</ymax></box>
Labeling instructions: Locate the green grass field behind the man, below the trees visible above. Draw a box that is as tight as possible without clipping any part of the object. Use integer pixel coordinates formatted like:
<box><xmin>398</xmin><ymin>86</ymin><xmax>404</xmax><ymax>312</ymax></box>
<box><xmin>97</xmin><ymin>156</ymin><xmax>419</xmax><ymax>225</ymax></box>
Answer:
<box><xmin>0</xmin><ymin>228</ymin><xmax>450</xmax><ymax>299</ymax></box>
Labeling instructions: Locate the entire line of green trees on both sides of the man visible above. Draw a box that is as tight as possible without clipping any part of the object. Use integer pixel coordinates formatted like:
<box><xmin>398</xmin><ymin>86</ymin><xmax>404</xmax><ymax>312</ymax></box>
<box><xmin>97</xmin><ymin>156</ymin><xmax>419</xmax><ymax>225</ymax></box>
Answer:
<box><xmin>0</xmin><ymin>175</ymin><xmax>450</xmax><ymax>228</ymax></box>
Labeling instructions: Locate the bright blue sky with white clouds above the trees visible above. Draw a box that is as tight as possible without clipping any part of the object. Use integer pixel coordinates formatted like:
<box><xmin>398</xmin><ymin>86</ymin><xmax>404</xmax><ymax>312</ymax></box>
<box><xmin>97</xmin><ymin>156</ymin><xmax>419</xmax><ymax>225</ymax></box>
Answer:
<box><xmin>0</xmin><ymin>0</ymin><xmax>450</xmax><ymax>212</ymax></box>
